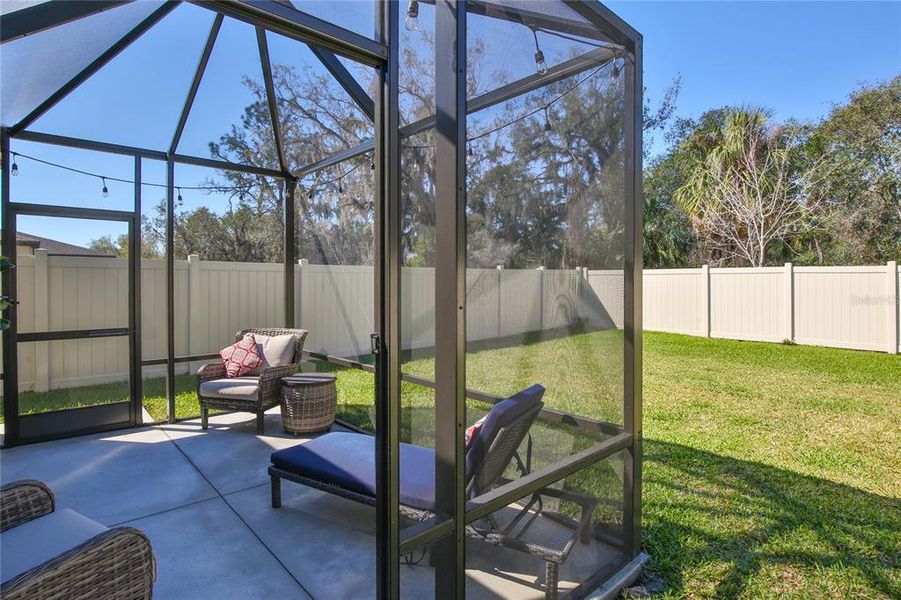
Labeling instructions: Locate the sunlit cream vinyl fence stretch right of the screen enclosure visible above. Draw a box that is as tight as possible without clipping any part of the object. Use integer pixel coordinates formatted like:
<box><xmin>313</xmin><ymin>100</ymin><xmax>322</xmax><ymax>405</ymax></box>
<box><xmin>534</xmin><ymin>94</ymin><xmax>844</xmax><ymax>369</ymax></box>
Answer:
<box><xmin>636</xmin><ymin>261</ymin><xmax>901</xmax><ymax>354</ymax></box>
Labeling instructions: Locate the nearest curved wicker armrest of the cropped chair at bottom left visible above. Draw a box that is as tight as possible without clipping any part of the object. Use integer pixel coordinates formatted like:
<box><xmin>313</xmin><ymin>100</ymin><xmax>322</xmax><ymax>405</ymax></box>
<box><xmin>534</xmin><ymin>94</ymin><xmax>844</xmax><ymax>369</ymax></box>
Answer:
<box><xmin>0</xmin><ymin>527</ymin><xmax>156</xmax><ymax>600</ymax></box>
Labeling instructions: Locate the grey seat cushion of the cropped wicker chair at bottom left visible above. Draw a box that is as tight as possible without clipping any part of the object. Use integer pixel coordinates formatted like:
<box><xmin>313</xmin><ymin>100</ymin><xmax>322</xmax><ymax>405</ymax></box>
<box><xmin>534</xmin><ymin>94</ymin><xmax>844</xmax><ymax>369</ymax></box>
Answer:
<box><xmin>0</xmin><ymin>508</ymin><xmax>107</xmax><ymax>582</ymax></box>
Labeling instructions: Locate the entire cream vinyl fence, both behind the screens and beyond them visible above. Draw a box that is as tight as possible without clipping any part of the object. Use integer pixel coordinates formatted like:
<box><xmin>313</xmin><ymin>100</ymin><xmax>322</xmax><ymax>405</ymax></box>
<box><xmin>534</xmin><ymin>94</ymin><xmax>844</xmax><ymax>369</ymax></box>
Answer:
<box><xmin>5</xmin><ymin>250</ymin><xmax>901</xmax><ymax>391</ymax></box>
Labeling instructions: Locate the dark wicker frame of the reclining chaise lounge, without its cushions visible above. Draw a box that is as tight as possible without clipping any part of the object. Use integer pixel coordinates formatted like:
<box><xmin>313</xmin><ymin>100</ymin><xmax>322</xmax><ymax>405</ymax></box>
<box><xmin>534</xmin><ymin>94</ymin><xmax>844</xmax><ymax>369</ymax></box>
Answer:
<box><xmin>269</xmin><ymin>392</ymin><xmax>599</xmax><ymax>600</ymax></box>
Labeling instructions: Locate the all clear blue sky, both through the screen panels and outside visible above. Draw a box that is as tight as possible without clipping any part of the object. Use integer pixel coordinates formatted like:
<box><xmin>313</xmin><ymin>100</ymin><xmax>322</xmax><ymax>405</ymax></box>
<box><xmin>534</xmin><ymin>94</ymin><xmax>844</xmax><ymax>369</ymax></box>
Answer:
<box><xmin>3</xmin><ymin>1</ymin><xmax>901</xmax><ymax>244</ymax></box>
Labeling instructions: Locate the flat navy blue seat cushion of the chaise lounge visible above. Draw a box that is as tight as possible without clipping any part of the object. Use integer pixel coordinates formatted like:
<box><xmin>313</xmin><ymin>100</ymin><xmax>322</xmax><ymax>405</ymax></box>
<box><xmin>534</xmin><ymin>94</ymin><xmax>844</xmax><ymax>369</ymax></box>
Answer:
<box><xmin>272</xmin><ymin>432</ymin><xmax>435</xmax><ymax>510</ymax></box>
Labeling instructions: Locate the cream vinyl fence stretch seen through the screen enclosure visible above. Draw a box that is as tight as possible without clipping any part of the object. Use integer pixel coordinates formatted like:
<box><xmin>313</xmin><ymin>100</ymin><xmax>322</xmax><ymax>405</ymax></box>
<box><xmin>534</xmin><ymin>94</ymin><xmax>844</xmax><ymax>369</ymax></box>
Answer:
<box><xmin>7</xmin><ymin>250</ymin><xmax>622</xmax><ymax>391</ymax></box>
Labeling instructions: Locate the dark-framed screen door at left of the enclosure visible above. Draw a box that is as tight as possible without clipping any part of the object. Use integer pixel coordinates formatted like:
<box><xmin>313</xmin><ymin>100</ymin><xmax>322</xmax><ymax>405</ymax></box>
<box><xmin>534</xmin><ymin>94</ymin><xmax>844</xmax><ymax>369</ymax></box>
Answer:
<box><xmin>4</xmin><ymin>203</ymin><xmax>140</xmax><ymax>444</ymax></box>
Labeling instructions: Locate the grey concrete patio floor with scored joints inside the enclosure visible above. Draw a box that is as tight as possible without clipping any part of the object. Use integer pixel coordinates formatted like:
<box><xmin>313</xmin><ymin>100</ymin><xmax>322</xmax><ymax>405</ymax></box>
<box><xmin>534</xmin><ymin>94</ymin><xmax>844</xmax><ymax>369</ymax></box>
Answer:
<box><xmin>0</xmin><ymin>408</ymin><xmax>615</xmax><ymax>600</ymax></box>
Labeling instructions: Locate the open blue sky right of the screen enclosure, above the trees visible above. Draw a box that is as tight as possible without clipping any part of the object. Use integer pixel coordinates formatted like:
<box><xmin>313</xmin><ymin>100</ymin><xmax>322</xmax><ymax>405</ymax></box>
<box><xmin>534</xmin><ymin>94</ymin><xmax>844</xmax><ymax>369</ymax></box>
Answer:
<box><xmin>606</xmin><ymin>1</ymin><xmax>901</xmax><ymax>155</ymax></box>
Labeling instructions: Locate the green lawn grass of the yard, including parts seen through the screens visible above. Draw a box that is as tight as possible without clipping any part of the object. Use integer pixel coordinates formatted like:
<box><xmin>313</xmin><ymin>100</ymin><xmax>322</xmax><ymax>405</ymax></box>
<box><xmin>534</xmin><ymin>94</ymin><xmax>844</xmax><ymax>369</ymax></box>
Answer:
<box><xmin>3</xmin><ymin>332</ymin><xmax>901</xmax><ymax>599</ymax></box>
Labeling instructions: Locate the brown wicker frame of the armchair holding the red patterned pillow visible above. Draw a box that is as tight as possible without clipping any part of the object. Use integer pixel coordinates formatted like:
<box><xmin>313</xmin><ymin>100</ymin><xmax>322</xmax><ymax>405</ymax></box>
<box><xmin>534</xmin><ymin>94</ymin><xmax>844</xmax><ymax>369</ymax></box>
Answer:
<box><xmin>197</xmin><ymin>327</ymin><xmax>307</xmax><ymax>435</ymax></box>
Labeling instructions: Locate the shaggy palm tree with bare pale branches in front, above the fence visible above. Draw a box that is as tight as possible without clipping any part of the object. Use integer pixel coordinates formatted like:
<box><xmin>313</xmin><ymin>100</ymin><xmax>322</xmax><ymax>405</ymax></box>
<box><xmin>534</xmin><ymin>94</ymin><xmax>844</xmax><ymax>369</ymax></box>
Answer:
<box><xmin>674</xmin><ymin>108</ymin><xmax>823</xmax><ymax>267</ymax></box>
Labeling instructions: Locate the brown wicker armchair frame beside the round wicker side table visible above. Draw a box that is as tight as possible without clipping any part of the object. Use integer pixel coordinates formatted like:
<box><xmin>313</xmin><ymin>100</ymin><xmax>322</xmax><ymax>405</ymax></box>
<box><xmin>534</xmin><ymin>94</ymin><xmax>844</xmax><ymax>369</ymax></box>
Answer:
<box><xmin>197</xmin><ymin>328</ymin><xmax>307</xmax><ymax>435</ymax></box>
